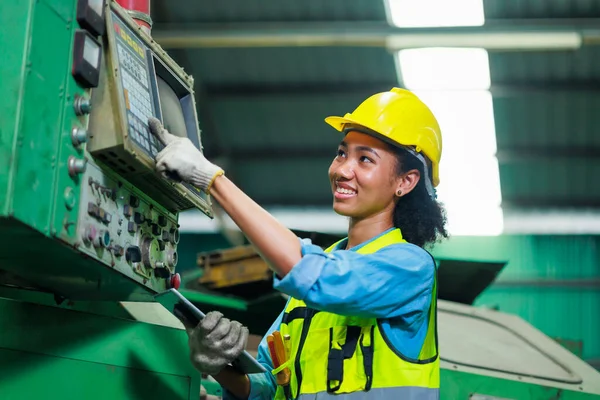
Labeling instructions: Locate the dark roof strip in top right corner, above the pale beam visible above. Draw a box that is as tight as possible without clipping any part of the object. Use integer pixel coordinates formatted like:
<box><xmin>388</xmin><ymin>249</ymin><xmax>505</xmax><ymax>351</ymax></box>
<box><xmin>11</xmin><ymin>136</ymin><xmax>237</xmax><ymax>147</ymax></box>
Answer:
<box><xmin>484</xmin><ymin>0</ymin><xmax>600</xmax><ymax>19</ymax></box>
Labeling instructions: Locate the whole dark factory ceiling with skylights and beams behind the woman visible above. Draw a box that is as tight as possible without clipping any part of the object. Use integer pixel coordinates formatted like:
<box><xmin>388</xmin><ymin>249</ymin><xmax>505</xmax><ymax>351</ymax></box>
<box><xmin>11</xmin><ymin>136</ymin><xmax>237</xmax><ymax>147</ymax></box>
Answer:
<box><xmin>152</xmin><ymin>0</ymin><xmax>600</xmax><ymax>234</ymax></box>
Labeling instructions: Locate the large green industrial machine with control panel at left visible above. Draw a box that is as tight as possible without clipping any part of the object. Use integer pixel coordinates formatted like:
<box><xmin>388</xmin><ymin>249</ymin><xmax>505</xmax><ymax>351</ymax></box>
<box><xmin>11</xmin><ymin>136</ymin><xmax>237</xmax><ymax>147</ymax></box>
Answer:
<box><xmin>0</xmin><ymin>0</ymin><xmax>212</xmax><ymax>400</ymax></box>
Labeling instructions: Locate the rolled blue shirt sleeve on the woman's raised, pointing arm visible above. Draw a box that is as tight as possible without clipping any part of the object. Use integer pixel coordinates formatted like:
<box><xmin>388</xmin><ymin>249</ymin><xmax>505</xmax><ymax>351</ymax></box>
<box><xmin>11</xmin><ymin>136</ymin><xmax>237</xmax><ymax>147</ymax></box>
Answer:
<box><xmin>274</xmin><ymin>236</ymin><xmax>435</xmax><ymax>318</ymax></box>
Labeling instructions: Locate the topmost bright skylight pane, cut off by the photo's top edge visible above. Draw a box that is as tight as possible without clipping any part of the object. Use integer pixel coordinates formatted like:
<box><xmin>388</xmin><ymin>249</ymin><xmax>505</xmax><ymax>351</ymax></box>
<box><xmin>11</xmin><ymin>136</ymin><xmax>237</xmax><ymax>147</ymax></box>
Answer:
<box><xmin>386</xmin><ymin>0</ymin><xmax>485</xmax><ymax>28</ymax></box>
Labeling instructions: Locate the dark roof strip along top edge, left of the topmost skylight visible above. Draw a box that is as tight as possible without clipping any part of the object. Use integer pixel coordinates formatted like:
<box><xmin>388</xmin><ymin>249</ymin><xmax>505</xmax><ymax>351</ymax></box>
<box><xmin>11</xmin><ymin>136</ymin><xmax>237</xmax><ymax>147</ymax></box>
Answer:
<box><xmin>152</xmin><ymin>0</ymin><xmax>386</xmax><ymax>23</ymax></box>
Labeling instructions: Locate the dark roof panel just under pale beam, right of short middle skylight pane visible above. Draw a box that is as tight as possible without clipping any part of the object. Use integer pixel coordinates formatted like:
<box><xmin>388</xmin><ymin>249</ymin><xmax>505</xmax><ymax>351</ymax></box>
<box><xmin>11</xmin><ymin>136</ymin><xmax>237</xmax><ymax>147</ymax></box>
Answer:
<box><xmin>489</xmin><ymin>48</ymin><xmax>600</xmax><ymax>84</ymax></box>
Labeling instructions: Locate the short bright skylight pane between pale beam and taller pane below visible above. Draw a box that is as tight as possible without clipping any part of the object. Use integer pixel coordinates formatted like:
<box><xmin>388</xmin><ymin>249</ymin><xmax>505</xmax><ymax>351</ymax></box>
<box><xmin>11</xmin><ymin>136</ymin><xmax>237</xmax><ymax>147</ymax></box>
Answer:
<box><xmin>397</xmin><ymin>48</ymin><xmax>490</xmax><ymax>90</ymax></box>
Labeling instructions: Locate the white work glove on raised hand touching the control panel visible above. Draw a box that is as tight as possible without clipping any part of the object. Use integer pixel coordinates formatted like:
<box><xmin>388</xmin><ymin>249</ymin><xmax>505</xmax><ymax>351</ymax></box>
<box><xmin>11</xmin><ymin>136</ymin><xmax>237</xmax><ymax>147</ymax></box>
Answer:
<box><xmin>148</xmin><ymin>118</ymin><xmax>224</xmax><ymax>193</ymax></box>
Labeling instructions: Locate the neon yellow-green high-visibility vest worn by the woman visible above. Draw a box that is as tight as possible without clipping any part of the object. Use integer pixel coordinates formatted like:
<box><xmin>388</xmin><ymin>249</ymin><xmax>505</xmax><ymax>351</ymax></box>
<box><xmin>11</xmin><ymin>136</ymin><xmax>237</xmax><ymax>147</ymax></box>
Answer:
<box><xmin>273</xmin><ymin>229</ymin><xmax>440</xmax><ymax>400</ymax></box>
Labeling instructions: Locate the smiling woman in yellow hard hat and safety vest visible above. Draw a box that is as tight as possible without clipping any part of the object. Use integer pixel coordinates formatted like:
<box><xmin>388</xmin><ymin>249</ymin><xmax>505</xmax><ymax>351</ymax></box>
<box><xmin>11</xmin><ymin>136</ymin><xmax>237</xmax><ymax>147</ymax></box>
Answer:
<box><xmin>150</xmin><ymin>88</ymin><xmax>447</xmax><ymax>399</ymax></box>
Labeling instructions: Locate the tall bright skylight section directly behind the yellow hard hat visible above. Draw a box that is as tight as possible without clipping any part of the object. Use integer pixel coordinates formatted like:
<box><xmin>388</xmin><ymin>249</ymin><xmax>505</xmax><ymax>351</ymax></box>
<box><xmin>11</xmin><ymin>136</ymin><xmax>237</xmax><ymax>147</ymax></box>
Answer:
<box><xmin>415</xmin><ymin>90</ymin><xmax>503</xmax><ymax>235</ymax></box>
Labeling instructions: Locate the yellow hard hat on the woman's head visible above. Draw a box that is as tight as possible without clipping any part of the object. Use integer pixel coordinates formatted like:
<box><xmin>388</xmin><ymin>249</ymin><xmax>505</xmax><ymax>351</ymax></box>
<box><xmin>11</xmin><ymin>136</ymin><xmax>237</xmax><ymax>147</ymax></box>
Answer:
<box><xmin>325</xmin><ymin>88</ymin><xmax>442</xmax><ymax>187</ymax></box>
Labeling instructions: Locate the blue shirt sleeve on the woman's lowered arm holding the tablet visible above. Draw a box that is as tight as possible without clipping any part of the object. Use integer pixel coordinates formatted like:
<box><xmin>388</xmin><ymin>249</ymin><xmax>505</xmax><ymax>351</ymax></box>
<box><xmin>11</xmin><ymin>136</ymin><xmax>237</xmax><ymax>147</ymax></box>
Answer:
<box><xmin>223</xmin><ymin>308</ymin><xmax>285</xmax><ymax>400</ymax></box>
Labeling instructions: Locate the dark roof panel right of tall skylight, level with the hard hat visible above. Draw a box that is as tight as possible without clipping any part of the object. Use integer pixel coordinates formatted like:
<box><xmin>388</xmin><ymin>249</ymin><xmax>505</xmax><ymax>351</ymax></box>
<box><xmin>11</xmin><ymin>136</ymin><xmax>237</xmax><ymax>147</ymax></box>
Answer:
<box><xmin>494</xmin><ymin>93</ymin><xmax>600</xmax><ymax>149</ymax></box>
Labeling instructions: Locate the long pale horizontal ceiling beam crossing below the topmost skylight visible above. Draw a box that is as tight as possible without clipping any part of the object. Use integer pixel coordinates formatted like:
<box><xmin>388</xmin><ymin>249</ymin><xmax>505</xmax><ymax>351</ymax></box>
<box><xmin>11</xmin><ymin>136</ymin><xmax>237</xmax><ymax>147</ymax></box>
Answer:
<box><xmin>152</xmin><ymin>18</ymin><xmax>600</xmax><ymax>50</ymax></box>
